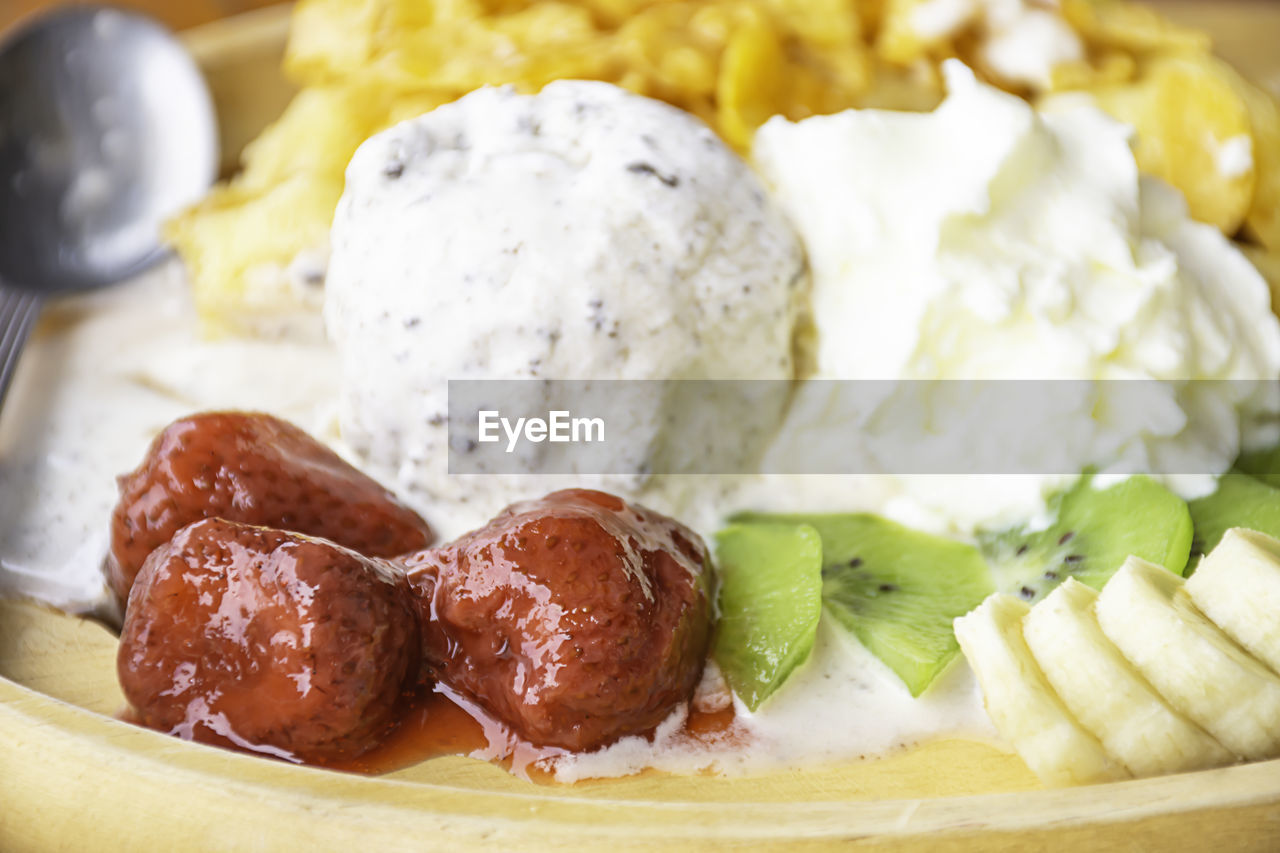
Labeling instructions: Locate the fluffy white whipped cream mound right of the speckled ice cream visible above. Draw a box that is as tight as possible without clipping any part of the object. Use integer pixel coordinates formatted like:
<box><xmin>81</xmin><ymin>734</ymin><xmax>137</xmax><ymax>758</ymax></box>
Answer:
<box><xmin>754</xmin><ymin>61</ymin><xmax>1280</xmax><ymax>528</ymax></box>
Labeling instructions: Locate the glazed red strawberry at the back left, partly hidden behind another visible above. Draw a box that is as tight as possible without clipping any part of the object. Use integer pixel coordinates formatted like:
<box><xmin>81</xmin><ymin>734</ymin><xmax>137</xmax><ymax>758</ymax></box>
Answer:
<box><xmin>106</xmin><ymin>411</ymin><xmax>434</xmax><ymax>603</ymax></box>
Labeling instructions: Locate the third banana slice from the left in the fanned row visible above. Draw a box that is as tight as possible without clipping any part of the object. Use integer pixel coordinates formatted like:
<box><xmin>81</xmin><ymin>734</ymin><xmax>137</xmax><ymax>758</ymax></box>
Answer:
<box><xmin>1094</xmin><ymin>557</ymin><xmax>1280</xmax><ymax>760</ymax></box>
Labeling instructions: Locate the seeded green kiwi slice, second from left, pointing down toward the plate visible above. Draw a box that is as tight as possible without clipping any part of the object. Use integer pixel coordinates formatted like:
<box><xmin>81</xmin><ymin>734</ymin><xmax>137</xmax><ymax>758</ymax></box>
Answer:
<box><xmin>745</xmin><ymin>514</ymin><xmax>992</xmax><ymax>697</ymax></box>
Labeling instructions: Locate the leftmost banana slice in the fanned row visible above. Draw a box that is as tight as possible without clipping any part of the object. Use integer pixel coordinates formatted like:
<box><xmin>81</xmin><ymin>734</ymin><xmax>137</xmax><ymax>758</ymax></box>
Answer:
<box><xmin>955</xmin><ymin>593</ymin><xmax>1129</xmax><ymax>785</ymax></box>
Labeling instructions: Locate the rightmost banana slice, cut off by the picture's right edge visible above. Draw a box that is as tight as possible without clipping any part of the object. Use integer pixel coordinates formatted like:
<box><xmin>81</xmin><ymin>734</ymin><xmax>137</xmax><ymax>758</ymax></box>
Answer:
<box><xmin>1187</xmin><ymin>528</ymin><xmax>1280</xmax><ymax>672</ymax></box>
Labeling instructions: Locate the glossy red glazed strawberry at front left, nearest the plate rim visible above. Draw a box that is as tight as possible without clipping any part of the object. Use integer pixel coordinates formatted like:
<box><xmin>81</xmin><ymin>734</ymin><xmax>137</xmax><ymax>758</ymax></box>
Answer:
<box><xmin>116</xmin><ymin>519</ymin><xmax>421</xmax><ymax>762</ymax></box>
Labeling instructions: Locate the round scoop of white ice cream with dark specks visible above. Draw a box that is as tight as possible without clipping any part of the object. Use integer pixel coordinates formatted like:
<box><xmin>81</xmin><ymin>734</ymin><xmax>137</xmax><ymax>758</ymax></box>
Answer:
<box><xmin>325</xmin><ymin>81</ymin><xmax>808</xmax><ymax>534</ymax></box>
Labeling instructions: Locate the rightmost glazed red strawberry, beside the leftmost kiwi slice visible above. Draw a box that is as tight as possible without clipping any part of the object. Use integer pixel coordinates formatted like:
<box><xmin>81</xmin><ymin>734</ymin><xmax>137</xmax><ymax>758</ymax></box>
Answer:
<box><xmin>406</xmin><ymin>489</ymin><xmax>712</xmax><ymax>751</ymax></box>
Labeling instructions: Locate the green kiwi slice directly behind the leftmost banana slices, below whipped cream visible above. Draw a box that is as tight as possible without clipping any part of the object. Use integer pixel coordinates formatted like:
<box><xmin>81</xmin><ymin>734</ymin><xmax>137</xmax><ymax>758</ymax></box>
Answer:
<box><xmin>978</xmin><ymin>474</ymin><xmax>1192</xmax><ymax>602</ymax></box>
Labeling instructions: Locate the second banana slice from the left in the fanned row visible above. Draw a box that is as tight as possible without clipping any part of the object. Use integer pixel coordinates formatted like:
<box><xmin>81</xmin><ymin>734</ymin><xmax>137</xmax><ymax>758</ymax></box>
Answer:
<box><xmin>1023</xmin><ymin>578</ymin><xmax>1235</xmax><ymax>776</ymax></box>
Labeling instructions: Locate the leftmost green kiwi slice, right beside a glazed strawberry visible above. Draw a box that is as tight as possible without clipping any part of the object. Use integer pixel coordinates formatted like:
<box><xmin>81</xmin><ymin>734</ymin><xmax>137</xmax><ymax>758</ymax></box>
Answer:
<box><xmin>714</xmin><ymin>524</ymin><xmax>822</xmax><ymax>711</ymax></box>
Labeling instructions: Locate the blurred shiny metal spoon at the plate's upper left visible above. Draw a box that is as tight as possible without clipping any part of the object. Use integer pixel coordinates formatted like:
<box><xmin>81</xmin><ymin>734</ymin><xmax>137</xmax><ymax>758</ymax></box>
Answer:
<box><xmin>0</xmin><ymin>6</ymin><xmax>218</xmax><ymax>405</ymax></box>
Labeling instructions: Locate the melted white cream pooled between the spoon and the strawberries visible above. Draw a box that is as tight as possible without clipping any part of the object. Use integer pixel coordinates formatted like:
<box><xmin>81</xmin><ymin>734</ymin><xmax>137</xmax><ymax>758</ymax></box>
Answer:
<box><xmin>0</xmin><ymin>264</ymin><xmax>335</xmax><ymax>612</ymax></box>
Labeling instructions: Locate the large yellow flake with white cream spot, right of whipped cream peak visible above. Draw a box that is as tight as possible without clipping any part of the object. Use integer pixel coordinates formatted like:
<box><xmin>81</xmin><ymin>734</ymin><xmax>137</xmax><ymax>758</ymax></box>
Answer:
<box><xmin>1093</xmin><ymin>55</ymin><xmax>1256</xmax><ymax>234</ymax></box>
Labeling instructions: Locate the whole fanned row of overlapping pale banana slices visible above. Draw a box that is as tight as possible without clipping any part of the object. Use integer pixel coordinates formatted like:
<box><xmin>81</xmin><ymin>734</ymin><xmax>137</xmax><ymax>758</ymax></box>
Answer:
<box><xmin>955</xmin><ymin>528</ymin><xmax>1280</xmax><ymax>785</ymax></box>
